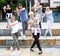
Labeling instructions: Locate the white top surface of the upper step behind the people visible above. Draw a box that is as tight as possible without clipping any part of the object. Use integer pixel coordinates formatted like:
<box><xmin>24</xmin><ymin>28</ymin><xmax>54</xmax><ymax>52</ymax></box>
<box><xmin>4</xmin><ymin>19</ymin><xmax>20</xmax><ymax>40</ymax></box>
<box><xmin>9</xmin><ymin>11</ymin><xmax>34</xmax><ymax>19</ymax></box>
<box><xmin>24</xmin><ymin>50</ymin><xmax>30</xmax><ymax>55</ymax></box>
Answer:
<box><xmin>0</xmin><ymin>22</ymin><xmax>60</xmax><ymax>29</ymax></box>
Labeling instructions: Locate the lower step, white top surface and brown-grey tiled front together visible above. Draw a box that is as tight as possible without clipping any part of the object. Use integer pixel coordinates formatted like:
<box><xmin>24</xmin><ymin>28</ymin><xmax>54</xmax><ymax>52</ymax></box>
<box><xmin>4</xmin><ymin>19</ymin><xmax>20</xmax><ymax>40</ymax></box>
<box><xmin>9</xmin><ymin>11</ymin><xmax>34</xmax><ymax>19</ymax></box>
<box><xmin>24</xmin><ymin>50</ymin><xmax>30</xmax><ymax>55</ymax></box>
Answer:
<box><xmin>0</xmin><ymin>36</ymin><xmax>60</xmax><ymax>47</ymax></box>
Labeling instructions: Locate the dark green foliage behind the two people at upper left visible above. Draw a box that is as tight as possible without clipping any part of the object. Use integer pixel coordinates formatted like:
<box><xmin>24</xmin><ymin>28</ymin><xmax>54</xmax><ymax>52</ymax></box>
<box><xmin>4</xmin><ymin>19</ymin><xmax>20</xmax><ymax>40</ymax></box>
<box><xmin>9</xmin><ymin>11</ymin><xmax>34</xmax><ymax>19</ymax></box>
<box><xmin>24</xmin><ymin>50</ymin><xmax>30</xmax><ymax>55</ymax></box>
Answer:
<box><xmin>0</xmin><ymin>0</ymin><xmax>26</xmax><ymax>10</ymax></box>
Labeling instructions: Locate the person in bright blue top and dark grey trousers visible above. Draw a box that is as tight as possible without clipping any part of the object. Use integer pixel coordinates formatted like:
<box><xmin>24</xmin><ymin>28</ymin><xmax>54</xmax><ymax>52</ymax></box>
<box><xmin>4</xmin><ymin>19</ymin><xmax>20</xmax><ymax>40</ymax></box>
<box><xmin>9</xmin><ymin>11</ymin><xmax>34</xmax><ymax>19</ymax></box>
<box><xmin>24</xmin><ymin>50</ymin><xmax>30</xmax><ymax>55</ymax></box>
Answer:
<box><xmin>18</xmin><ymin>3</ymin><xmax>28</xmax><ymax>38</ymax></box>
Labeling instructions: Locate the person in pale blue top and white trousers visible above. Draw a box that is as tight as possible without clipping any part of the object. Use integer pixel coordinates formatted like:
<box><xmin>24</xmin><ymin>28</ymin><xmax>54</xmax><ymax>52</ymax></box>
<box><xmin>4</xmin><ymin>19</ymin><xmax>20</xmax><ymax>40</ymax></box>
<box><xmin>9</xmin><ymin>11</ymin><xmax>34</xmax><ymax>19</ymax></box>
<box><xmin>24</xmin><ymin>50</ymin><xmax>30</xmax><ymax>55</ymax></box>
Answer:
<box><xmin>44</xmin><ymin>6</ymin><xmax>53</xmax><ymax>37</ymax></box>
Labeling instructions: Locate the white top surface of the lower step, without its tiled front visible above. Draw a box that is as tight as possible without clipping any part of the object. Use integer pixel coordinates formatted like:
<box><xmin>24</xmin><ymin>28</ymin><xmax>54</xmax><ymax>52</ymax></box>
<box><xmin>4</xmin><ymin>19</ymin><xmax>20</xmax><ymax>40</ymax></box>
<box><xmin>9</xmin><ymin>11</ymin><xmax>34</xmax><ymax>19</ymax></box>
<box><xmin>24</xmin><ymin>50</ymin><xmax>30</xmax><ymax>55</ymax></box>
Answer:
<box><xmin>0</xmin><ymin>36</ymin><xmax>60</xmax><ymax>40</ymax></box>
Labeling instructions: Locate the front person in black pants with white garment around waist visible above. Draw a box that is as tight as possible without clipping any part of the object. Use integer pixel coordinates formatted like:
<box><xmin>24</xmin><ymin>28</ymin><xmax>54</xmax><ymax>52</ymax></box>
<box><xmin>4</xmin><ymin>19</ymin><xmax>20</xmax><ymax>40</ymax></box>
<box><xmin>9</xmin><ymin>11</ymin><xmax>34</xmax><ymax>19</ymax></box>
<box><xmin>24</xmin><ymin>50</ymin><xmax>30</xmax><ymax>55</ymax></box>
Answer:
<box><xmin>28</xmin><ymin>12</ymin><xmax>42</xmax><ymax>54</ymax></box>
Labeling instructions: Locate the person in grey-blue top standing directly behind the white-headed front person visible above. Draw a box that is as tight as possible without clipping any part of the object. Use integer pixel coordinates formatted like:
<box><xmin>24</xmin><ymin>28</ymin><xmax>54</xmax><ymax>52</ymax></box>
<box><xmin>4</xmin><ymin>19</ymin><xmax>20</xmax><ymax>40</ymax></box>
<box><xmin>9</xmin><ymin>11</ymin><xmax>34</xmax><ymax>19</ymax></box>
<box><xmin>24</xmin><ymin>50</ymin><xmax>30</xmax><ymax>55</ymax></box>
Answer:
<box><xmin>33</xmin><ymin>1</ymin><xmax>42</xmax><ymax>34</ymax></box>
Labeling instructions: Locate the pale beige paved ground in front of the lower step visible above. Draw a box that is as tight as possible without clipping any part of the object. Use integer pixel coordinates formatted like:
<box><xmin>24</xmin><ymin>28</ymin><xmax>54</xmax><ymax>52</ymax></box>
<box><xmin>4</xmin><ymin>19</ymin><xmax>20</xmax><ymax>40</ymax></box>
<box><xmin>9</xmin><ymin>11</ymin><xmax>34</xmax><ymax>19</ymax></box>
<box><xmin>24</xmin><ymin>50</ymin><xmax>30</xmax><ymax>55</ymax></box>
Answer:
<box><xmin>0</xmin><ymin>48</ymin><xmax>60</xmax><ymax>56</ymax></box>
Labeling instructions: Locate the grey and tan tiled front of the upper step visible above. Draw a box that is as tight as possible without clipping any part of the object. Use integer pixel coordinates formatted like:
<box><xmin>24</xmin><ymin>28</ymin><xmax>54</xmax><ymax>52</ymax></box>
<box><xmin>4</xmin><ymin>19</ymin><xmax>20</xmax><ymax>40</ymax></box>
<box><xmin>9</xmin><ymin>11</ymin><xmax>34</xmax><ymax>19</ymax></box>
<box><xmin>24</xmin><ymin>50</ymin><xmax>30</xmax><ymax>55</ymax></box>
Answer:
<box><xmin>0</xmin><ymin>29</ymin><xmax>60</xmax><ymax>36</ymax></box>
